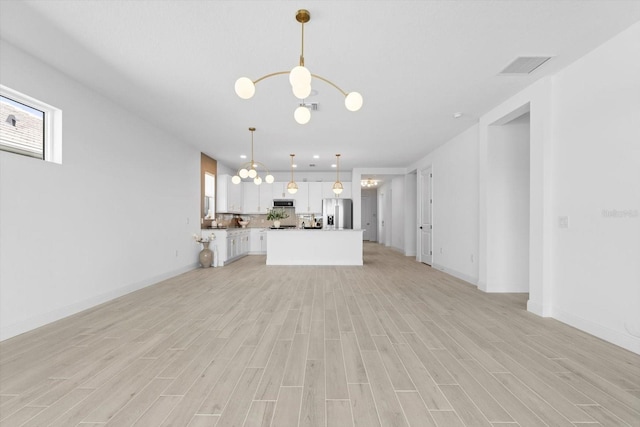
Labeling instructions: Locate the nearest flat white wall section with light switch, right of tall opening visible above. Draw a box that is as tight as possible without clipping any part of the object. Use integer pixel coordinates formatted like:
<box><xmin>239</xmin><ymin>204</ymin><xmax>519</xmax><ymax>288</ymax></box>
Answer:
<box><xmin>552</xmin><ymin>23</ymin><xmax>640</xmax><ymax>353</ymax></box>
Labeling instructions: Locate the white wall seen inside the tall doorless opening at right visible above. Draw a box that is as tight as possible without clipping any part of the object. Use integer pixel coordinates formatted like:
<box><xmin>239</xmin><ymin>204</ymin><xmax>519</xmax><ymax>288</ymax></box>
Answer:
<box><xmin>487</xmin><ymin>114</ymin><xmax>530</xmax><ymax>292</ymax></box>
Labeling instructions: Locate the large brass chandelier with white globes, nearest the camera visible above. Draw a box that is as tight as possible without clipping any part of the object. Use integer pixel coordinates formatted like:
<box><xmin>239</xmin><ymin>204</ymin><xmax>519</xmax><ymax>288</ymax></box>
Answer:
<box><xmin>235</xmin><ymin>9</ymin><xmax>362</xmax><ymax>125</ymax></box>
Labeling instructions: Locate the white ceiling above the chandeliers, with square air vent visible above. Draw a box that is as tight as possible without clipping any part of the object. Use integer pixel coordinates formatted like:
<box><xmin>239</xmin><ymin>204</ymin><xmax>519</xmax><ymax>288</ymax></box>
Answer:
<box><xmin>0</xmin><ymin>0</ymin><xmax>640</xmax><ymax>171</ymax></box>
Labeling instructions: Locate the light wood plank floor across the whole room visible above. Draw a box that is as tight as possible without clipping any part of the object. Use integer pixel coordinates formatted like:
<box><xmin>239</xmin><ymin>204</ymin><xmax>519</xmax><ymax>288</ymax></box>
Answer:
<box><xmin>0</xmin><ymin>243</ymin><xmax>640</xmax><ymax>427</ymax></box>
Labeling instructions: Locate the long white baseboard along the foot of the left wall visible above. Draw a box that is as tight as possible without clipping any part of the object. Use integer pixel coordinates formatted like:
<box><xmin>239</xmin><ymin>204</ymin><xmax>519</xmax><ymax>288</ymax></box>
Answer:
<box><xmin>0</xmin><ymin>264</ymin><xmax>199</xmax><ymax>341</ymax></box>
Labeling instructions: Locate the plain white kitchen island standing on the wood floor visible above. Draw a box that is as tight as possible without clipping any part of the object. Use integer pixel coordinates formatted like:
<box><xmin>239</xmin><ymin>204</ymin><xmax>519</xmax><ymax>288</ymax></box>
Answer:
<box><xmin>267</xmin><ymin>229</ymin><xmax>363</xmax><ymax>265</ymax></box>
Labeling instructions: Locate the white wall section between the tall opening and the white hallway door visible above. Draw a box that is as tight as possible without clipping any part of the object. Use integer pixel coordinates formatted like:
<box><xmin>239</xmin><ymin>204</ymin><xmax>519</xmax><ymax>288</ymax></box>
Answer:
<box><xmin>408</xmin><ymin>124</ymin><xmax>478</xmax><ymax>285</ymax></box>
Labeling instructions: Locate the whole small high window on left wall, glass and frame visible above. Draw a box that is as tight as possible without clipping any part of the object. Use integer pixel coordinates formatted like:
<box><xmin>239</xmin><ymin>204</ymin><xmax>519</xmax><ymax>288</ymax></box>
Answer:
<box><xmin>0</xmin><ymin>85</ymin><xmax>62</xmax><ymax>163</ymax></box>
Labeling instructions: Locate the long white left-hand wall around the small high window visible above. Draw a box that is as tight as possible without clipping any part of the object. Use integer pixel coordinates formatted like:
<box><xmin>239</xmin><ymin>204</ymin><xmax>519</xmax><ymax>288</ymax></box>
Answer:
<box><xmin>0</xmin><ymin>41</ymin><xmax>200</xmax><ymax>339</ymax></box>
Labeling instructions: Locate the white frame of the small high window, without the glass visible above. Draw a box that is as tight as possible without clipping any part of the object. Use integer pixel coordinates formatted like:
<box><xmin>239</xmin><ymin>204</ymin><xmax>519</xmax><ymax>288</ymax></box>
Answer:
<box><xmin>0</xmin><ymin>84</ymin><xmax>62</xmax><ymax>164</ymax></box>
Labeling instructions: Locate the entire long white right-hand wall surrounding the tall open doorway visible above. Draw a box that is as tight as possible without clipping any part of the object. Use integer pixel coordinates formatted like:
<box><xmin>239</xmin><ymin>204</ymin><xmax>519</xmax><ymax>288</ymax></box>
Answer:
<box><xmin>407</xmin><ymin>23</ymin><xmax>640</xmax><ymax>353</ymax></box>
